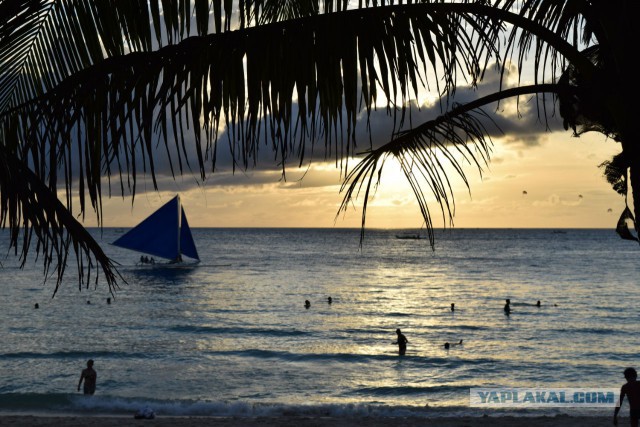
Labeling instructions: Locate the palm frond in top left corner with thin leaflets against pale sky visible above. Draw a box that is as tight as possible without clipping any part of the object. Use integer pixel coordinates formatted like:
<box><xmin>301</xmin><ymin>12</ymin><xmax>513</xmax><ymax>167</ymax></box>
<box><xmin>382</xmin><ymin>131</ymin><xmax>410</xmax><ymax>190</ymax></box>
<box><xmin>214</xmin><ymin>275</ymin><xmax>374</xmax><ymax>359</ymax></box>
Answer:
<box><xmin>0</xmin><ymin>0</ymin><xmax>232</xmax><ymax>112</ymax></box>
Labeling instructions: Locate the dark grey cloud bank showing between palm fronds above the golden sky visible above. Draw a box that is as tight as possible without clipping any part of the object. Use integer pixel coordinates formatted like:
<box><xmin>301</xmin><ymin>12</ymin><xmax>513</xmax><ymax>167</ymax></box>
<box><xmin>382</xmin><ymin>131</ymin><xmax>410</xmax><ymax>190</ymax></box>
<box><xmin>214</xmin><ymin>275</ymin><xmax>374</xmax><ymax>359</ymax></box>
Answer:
<box><xmin>65</xmin><ymin>64</ymin><xmax>561</xmax><ymax>194</ymax></box>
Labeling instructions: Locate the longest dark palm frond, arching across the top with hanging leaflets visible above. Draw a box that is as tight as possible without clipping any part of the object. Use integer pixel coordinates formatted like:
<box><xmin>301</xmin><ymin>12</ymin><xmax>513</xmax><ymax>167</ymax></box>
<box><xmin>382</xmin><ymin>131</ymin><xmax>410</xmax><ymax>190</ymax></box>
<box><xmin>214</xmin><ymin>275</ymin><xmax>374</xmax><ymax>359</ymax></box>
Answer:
<box><xmin>5</xmin><ymin>3</ymin><xmax>502</xmax><ymax>191</ymax></box>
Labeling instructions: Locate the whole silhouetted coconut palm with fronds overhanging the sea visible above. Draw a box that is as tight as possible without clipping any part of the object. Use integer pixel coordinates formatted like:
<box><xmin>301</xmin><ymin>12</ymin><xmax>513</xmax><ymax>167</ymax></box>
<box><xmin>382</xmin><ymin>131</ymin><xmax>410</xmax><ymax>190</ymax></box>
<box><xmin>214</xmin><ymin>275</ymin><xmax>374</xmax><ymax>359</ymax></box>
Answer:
<box><xmin>0</xmin><ymin>0</ymin><xmax>640</xmax><ymax>290</ymax></box>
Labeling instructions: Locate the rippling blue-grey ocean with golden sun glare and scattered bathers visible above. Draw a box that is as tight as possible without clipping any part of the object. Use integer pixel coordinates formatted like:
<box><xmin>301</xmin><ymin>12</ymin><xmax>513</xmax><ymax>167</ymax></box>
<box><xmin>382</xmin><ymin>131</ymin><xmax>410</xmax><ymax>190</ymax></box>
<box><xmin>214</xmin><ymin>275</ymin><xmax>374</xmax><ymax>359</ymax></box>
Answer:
<box><xmin>0</xmin><ymin>228</ymin><xmax>640</xmax><ymax>417</ymax></box>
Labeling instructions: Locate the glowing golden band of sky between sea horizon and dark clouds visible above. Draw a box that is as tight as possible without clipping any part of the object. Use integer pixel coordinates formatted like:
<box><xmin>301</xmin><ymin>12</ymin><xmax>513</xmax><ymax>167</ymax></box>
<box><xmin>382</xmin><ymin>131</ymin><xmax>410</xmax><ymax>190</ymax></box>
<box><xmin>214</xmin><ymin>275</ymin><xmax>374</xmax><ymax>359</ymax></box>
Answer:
<box><xmin>96</xmin><ymin>132</ymin><xmax>624</xmax><ymax>229</ymax></box>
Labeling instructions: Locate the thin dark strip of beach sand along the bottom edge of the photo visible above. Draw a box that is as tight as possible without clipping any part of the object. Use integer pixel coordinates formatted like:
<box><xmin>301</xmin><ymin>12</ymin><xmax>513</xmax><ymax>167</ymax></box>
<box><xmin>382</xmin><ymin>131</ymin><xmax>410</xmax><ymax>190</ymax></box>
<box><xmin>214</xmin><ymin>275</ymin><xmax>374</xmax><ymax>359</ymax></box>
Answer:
<box><xmin>0</xmin><ymin>414</ymin><xmax>616</xmax><ymax>427</ymax></box>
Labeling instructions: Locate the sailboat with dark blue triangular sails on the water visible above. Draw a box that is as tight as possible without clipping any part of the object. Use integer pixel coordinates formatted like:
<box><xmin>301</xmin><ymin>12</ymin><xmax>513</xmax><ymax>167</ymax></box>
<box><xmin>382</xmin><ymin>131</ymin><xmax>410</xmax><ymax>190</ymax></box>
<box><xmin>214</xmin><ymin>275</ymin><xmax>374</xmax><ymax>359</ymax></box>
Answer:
<box><xmin>112</xmin><ymin>195</ymin><xmax>200</xmax><ymax>264</ymax></box>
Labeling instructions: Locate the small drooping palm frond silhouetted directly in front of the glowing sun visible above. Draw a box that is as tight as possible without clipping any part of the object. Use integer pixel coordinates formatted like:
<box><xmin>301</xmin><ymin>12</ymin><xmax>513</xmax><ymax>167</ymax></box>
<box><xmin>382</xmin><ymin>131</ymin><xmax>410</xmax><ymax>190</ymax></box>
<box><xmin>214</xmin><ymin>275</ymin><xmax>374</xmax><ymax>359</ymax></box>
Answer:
<box><xmin>339</xmin><ymin>84</ymin><xmax>573</xmax><ymax>248</ymax></box>
